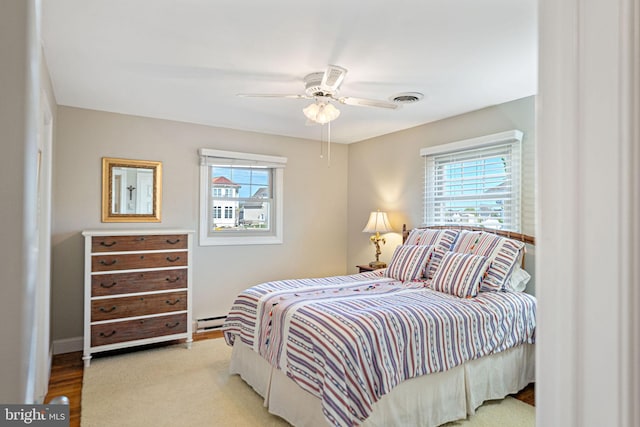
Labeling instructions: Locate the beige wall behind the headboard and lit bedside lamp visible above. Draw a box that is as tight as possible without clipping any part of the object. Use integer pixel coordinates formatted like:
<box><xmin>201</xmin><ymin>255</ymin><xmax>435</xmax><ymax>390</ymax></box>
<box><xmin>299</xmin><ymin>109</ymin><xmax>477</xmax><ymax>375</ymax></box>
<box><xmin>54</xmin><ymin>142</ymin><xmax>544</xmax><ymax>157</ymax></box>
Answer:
<box><xmin>347</xmin><ymin>97</ymin><xmax>535</xmax><ymax>291</ymax></box>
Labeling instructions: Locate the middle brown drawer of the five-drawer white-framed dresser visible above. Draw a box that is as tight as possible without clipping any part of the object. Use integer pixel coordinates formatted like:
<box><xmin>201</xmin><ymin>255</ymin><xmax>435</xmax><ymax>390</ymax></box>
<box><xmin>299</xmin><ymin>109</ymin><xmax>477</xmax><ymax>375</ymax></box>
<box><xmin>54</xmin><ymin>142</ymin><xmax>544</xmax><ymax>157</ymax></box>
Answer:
<box><xmin>91</xmin><ymin>268</ymin><xmax>187</xmax><ymax>297</ymax></box>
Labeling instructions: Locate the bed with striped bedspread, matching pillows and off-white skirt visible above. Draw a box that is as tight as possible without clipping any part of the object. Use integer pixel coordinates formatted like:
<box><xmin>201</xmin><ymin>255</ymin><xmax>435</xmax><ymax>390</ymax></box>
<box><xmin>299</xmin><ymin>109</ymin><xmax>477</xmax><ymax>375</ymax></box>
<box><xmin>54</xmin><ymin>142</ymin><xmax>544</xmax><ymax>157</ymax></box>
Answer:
<box><xmin>223</xmin><ymin>229</ymin><xmax>536</xmax><ymax>426</ymax></box>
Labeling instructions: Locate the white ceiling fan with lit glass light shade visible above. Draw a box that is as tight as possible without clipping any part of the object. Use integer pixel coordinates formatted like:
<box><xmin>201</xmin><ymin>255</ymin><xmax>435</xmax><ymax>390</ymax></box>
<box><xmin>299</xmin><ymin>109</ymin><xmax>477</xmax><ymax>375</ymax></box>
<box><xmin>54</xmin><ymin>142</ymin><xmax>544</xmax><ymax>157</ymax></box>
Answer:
<box><xmin>238</xmin><ymin>65</ymin><xmax>399</xmax><ymax>124</ymax></box>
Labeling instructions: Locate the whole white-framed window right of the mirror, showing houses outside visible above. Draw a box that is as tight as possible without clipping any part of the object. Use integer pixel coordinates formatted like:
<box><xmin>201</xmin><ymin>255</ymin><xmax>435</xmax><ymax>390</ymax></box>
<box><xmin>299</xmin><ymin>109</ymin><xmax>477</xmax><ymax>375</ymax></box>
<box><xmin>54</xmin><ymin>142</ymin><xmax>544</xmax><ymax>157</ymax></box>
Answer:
<box><xmin>199</xmin><ymin>148</ymin><xmax>287</xmax><ymax>246</ymax></box>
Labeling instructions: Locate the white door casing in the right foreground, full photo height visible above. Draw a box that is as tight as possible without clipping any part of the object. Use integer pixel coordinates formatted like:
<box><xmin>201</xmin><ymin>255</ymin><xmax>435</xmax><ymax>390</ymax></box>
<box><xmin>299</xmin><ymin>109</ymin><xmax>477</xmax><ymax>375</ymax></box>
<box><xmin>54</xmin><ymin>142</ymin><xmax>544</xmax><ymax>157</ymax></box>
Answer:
<box><xmin>536</xmin><ymin>0</ymin><xmax>640</xmax><ymax>427</ymax></box>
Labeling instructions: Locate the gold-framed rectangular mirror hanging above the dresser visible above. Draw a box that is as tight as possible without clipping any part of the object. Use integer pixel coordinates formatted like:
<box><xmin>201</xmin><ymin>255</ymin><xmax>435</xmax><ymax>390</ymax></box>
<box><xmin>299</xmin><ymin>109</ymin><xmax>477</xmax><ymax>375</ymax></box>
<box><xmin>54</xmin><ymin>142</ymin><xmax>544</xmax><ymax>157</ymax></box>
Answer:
<box><xmin>102</xmin><ymin>157</ymin><xmax>162</xmax><ymax>222</ymax></box>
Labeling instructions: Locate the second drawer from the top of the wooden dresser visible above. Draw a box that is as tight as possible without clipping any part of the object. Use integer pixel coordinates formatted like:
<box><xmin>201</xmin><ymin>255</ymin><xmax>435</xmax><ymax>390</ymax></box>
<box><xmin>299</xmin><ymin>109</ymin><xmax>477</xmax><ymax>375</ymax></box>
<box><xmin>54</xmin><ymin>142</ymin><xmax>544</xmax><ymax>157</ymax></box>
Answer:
<box><xmin>91</xmin><ymin>251</ymin><xmax>187</xmax><ymax>271</ymax></box>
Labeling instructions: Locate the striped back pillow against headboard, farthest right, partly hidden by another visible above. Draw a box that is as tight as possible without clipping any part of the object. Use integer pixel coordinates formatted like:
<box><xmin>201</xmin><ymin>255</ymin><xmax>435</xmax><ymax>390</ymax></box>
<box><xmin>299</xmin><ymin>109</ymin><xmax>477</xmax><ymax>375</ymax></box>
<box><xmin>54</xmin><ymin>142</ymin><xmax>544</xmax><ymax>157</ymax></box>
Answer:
<box><xmin>452</xmin><ymin>231</ymin><xmax>524</xmax><ymax>291</ymax></box>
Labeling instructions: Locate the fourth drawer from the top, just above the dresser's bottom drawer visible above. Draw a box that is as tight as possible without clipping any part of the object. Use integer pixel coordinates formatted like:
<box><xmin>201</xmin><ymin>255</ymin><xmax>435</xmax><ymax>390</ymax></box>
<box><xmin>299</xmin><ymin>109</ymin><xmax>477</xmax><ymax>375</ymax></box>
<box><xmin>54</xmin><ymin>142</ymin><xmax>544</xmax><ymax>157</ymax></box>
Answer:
<box><xmin>91</xmin><ymin>291</ymin><xmax>187</xmax><ymax>322</ymax></box>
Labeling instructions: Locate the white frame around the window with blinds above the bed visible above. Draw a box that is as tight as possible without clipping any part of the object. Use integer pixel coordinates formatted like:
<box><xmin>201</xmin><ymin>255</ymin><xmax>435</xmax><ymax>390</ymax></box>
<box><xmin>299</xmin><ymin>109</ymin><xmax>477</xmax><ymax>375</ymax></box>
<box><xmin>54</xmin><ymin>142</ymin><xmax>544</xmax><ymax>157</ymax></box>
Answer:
<box><xmin>420</xmin><ymin>130</ymin><xmax>523</xmax><ymax>232</ymax></box>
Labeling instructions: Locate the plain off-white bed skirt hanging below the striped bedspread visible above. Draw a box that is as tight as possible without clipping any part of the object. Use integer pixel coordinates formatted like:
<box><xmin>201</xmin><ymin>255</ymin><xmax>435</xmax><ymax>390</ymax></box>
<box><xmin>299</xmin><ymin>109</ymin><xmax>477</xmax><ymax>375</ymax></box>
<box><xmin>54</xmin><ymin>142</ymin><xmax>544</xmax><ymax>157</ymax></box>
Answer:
<box><xmin>229</xmin><ymin>340</ymin><xmax>535</xmax><ymax>427</ymax></box>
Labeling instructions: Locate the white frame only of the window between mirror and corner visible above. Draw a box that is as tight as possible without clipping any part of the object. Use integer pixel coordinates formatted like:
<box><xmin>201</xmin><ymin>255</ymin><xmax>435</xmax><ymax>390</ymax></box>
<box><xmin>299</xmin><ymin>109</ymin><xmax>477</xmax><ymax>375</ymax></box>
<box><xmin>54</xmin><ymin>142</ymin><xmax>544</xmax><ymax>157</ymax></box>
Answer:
<box><xmin>198</xmin><ymin>148</ymin><xmax>287</xmax><ymax>246</ymax></box>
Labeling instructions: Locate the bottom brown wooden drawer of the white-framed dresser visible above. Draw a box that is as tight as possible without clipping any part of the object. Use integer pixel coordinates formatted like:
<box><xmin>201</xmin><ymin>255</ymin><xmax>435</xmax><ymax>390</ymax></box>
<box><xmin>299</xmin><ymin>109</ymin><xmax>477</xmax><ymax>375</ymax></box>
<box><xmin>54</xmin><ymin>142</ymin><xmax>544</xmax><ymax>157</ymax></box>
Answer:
<box><xmin>91</xmin><ymin>313</ymin><xmax>187</xmax><ymax>346</ymax></box>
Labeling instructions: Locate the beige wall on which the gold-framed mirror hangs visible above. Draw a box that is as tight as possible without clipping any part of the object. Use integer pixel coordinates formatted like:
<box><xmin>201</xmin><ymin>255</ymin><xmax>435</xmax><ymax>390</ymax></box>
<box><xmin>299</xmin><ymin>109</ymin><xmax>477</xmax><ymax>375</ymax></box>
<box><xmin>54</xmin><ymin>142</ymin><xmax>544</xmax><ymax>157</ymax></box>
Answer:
<box><xmin>52</xmin><ymin>106</ymin><xmax>348</xmax><ymax>340</ymax></box>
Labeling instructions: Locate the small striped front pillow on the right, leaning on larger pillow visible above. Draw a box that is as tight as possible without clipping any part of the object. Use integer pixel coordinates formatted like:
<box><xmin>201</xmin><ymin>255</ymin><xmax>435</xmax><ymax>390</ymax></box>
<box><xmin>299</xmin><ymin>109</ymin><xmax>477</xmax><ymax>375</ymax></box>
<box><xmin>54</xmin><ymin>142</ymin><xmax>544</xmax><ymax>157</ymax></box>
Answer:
<box><xmin>431</xmin><ymin>252</ymin><xmax>490</xmax><ymax>298</ymax></box>
